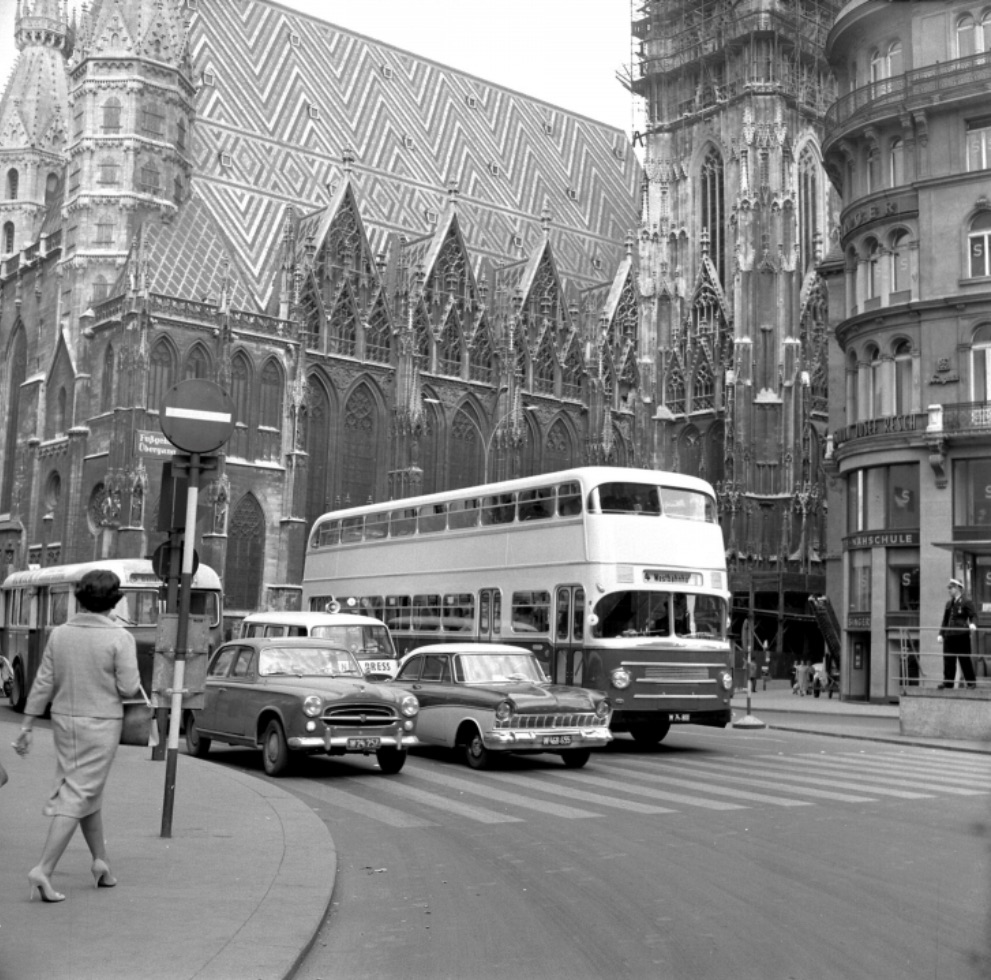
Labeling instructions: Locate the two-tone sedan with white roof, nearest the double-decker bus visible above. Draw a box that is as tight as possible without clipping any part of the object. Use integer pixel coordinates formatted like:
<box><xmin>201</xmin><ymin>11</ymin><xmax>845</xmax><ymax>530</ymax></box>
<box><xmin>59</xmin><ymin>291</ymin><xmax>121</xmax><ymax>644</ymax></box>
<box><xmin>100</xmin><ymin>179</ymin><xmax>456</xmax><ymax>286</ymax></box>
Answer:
<box><xmin>386</xmin><ymin>643</ymin><xmax>612</xmax><ymax>769</ymax></box>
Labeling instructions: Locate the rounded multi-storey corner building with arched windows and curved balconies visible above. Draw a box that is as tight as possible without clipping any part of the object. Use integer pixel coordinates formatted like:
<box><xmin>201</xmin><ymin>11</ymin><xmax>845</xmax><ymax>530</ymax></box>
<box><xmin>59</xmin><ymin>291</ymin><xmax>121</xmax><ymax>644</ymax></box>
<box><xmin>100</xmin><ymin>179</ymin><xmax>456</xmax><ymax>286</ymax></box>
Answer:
<box><xmin>822</xmin><ymin>0</ymin><xmax>991</xmax><ymax>700</ymax></box>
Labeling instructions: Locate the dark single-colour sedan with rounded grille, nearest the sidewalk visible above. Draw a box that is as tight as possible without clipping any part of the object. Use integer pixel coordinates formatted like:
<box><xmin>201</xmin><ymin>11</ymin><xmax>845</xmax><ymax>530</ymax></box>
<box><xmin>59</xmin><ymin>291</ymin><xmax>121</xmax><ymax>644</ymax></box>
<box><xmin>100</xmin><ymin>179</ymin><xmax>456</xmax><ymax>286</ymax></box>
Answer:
<box><xmin>184</xmin><ymin>637</ymin><xmax>420</xmax><ymax>776</ymax></box>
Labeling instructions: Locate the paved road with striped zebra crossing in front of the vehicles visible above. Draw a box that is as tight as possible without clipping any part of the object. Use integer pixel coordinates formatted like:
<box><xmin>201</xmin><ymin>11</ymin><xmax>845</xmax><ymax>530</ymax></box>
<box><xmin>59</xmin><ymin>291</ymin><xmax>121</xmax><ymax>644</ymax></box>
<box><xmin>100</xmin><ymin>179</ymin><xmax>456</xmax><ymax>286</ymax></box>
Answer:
<box><xmin>200</xmin><ymin>729</ymin><xmax>991</xmax><ymax>980</ymax></box>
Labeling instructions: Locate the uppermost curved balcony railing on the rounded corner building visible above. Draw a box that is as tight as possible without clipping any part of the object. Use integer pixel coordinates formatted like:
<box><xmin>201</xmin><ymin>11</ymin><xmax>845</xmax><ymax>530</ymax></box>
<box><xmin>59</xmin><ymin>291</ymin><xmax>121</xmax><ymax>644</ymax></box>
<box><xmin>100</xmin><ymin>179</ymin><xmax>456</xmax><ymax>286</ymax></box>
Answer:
<box><xmin>826</xmin><ymin>53</ymin><xmax>991</xmax><ymax>142</ymax></box>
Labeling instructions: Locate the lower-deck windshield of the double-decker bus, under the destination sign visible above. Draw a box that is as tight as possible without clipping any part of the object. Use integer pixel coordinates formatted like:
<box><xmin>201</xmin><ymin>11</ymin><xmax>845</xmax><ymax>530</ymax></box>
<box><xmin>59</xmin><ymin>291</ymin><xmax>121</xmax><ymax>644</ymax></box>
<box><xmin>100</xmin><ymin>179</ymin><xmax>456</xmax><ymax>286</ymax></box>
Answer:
<box><xmin>592</xmin><ymin>591</ymin><xmax>726</xmax><ymax>640</ymax></box>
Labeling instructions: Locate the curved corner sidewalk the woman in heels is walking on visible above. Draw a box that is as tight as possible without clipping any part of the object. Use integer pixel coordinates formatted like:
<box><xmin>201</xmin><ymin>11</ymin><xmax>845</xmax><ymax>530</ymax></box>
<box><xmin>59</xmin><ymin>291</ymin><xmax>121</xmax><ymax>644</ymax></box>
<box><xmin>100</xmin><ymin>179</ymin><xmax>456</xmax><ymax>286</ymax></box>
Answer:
<box><xmin>0</xmin><ymin>712</ymin><xmax>337</xmax><ymax>980</ymax></box>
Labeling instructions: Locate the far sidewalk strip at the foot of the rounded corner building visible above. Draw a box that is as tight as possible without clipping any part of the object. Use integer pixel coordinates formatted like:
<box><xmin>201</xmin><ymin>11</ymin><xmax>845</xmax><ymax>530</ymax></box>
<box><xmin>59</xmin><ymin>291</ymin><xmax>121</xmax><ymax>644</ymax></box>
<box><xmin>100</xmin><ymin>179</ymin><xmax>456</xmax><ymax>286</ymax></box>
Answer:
<box><xmin>732</xmin><ymin>680</ymin><xmax>991</xmax><ymax>755</ymax></box>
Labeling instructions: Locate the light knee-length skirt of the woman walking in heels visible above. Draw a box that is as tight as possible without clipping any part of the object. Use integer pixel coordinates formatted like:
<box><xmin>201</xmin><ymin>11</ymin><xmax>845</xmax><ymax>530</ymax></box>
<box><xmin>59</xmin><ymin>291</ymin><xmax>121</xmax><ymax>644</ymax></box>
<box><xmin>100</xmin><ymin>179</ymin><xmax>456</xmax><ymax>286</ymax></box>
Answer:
<box><xmin>43</xmin><ymin>712</ymin><xmax>122</xmax><ymax>818</ymax></box>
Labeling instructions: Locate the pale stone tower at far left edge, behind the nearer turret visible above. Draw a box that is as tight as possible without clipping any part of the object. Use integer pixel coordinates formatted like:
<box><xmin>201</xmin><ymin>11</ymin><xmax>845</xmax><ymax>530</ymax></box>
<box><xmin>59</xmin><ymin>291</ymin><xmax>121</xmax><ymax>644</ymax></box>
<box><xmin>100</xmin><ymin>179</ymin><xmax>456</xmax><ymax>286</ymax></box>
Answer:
<box><xmin>0</xmin><ymin>0</ymin><xmax>73</xmax><ymax>256</ymax></box>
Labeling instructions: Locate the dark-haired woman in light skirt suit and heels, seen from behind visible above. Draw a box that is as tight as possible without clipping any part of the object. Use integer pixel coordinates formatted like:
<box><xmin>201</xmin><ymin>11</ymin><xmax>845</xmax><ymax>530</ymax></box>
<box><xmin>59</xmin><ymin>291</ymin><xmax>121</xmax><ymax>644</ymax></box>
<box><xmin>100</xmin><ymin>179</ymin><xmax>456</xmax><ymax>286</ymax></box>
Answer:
<box><xmin>14</xmin><ymin>569</ymin><xmax>141</xmax><ymax>902</ymax></box>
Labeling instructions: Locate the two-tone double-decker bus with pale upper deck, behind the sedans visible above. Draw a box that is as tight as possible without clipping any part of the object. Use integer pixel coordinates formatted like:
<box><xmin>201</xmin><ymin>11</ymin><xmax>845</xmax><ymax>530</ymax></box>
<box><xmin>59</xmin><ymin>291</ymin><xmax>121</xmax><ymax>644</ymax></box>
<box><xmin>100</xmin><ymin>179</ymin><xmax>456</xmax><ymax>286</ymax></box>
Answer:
<box><xmin>303</xmin><ymin>467</ymin><xmax>733</xmax><ymax>745</ymax></box>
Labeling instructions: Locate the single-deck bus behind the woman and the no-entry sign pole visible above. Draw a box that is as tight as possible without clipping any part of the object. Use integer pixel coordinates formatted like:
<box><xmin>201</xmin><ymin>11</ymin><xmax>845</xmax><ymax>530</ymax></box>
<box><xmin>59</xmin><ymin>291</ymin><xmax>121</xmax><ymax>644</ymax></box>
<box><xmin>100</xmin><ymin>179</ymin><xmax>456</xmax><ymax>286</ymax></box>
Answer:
<box><xmin>0</xmin><ymin>558</ymin><xmax>224</xmax><ymax>711</ymax></box>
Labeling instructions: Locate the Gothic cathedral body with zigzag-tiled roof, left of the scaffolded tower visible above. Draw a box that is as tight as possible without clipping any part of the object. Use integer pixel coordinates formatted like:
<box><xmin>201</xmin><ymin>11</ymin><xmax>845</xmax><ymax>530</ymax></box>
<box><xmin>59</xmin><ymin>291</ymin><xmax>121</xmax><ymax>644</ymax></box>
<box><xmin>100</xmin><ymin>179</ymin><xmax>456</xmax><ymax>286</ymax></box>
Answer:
<box><xmin>0</xmin><ymin>0</ymin><xmax>640</xmax><ymax>613</ymax></box>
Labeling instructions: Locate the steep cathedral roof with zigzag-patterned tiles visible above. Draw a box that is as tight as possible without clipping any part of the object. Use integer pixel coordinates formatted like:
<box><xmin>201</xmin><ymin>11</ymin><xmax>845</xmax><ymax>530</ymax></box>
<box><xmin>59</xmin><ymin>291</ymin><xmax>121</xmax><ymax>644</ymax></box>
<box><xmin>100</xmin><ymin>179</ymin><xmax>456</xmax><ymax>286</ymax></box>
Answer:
<box><xmin>160</xmin><ymin>0</ymin><xmax>640</xmax><ymax>310</ymax></box>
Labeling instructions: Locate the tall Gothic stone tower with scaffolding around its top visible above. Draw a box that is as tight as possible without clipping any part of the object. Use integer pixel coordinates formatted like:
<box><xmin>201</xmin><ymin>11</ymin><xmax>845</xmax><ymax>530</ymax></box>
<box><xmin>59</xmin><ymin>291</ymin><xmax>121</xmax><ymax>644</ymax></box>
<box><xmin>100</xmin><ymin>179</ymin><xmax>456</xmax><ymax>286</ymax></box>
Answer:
<box><xmin>631</xmin><ymin>0</ymin><xmax>840</xmax><ymax>672</ymax></box>
